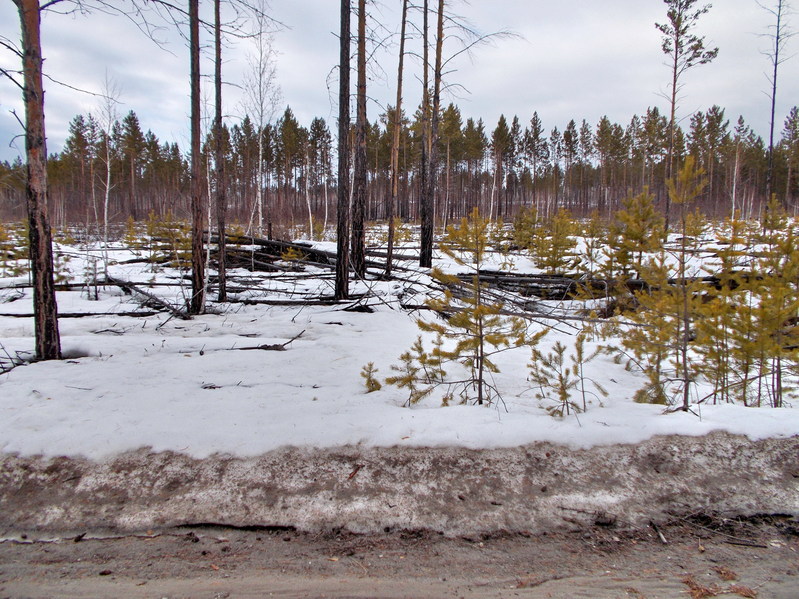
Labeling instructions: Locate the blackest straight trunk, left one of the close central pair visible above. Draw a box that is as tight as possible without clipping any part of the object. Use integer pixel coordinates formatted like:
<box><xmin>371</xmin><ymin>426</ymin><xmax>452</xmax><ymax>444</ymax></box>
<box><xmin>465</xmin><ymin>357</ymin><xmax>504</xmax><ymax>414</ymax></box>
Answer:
<box><xmin>335</xmin><ymin>0</ymin><xmax>350</xmax><ymax>299</ymax></box>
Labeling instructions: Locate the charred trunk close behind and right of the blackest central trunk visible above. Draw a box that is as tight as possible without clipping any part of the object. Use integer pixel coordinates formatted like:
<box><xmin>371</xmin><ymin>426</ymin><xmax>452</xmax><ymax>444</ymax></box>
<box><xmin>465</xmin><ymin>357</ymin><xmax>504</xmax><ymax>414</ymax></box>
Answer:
<box><xmin>352</xmin><ymin>0</ymin><xmax>367</xmax><ymax>278</ymax></box>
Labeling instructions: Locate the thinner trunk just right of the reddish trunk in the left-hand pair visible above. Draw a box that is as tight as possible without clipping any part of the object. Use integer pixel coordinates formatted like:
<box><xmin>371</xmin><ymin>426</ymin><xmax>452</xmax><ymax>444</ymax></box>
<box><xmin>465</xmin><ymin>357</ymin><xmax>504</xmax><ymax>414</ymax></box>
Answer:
<box><xmin>214</xmin><ymin>0</ymin><xmax>227</xmax><ymax>302</ymax></box>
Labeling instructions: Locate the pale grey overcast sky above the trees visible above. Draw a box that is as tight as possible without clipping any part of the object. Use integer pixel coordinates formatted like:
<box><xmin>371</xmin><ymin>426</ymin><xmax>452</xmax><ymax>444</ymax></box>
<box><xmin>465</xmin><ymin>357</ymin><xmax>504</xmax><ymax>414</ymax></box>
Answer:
<box><xmin>0</xmin><ymin>0</ymin><xmax>799</xmax><ymax>160</ymax></box>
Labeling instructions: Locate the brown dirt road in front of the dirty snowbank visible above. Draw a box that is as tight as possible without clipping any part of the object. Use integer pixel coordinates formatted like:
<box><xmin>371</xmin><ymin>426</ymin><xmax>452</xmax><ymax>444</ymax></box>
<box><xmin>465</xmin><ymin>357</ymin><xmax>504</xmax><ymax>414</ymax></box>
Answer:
<box><xmin>0</xmin><ymin>517</ymin><xmax>799</xmax><ymax>599</ymax></box>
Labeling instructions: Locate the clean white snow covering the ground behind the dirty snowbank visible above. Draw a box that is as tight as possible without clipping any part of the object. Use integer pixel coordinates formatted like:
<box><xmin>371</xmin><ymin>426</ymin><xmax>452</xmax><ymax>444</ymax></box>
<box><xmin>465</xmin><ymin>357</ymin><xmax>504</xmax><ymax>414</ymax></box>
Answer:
<box><xmin>0</xmin><ymin>237</ymin><xmax>799</xmax><ymax>460</ymax></box>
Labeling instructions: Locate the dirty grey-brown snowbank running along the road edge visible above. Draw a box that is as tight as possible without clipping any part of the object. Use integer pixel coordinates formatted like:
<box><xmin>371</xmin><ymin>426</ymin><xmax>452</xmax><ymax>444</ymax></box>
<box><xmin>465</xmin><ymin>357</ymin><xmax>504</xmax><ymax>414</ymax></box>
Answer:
<box><xmin>0</xmin><ymin>433</ymin><xmax>799</xmax><ymax>536</ymax></box>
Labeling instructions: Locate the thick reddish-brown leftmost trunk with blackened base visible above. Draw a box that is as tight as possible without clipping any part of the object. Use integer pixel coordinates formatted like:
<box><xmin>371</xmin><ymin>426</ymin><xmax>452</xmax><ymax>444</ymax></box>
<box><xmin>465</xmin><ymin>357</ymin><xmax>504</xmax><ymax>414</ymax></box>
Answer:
<box><xmin>14</xmin><ymin>0</ymin><xmax>61</xmax><ymax>360</ymax></box>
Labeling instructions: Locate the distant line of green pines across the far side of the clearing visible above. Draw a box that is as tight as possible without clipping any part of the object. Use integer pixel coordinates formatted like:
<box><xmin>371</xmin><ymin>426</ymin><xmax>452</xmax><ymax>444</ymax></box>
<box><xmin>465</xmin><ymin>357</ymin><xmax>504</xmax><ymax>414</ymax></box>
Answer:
<box><xmin>0</xmin><ymin>104</ymin><xmax>799</xmax><ymax>227</ymax></box>
